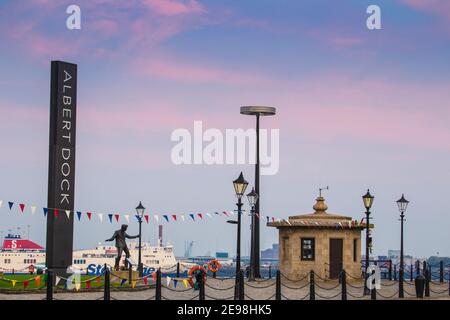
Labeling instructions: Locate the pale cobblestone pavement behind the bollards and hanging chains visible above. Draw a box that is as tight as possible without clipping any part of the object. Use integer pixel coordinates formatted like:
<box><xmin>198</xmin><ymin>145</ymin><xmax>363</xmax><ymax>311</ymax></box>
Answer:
<box><xmin>0</xmin><ymin>278</ymin><xmax>450</xmax><ymax>300</ymax></box>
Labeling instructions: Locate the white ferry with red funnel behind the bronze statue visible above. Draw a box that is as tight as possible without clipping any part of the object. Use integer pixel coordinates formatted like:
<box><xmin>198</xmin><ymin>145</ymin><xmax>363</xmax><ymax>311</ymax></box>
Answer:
<box><xmin>0</xmin><ymin>234</ymin><xmax>182</xmax><ymax>275</ymax></box>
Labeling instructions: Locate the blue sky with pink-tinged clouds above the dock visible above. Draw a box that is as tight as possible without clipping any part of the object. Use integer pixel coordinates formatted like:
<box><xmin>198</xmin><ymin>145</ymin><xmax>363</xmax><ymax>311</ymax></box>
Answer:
<box><xmin>0</xmin><ymin>0</ymin><xmax>450</xmax><ymax>257</ymax></box>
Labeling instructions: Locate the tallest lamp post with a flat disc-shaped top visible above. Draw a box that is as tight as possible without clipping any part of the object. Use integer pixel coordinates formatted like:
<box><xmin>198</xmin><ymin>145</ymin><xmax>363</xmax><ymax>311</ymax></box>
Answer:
<box><xmin>241</xmin><ymin>106</ymin><xmax>276</xmax><ymax>278</ymax></box>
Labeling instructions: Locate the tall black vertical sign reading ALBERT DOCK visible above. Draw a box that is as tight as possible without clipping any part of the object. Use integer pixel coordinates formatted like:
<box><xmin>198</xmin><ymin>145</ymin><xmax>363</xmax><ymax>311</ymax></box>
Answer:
<box><xmin>46</xmin><ymin>61</ymin><xmax>77</xmax><ymax>275</ymax></box>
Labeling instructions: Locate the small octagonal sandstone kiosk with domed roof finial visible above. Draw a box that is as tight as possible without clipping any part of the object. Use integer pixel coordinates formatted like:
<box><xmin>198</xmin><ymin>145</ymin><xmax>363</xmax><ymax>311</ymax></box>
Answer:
<box><xmin>267</xmin><ymin>196</ymin><xmax>365</xmax><ymax>279</ymax></box>
